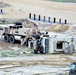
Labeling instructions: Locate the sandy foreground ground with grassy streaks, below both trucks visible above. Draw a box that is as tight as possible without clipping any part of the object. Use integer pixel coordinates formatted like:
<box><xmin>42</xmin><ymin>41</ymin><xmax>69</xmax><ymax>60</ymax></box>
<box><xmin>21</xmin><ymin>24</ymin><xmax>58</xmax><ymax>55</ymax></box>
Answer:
<box><xmin>0</xmin><ymin>36</ymin><xmax>76</xmax><ymax>75</ymax></box>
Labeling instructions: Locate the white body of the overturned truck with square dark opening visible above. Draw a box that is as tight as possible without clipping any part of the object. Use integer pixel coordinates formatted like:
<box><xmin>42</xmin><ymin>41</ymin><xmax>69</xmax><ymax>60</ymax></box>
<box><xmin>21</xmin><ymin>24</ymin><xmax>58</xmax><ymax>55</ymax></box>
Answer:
<box><xmin>41</xmin><ymin>32</ymin><xmax>76</xmax><ymax>53</ymax></box>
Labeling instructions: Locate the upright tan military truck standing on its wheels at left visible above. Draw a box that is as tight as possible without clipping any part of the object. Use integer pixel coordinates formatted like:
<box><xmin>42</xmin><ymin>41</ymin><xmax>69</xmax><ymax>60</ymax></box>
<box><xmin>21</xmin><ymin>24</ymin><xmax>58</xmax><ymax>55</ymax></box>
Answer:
<box><xmin>0</xmin><ymin>23</ymin><xmax>32</xmax><ymax>45</ymax></box>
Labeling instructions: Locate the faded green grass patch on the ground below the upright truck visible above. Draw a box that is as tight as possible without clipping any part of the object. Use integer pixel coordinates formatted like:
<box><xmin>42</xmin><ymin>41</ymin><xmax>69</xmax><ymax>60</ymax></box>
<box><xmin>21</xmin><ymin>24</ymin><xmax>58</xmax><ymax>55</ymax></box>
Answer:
<box><xmin>0</xmin><ymin>48</ymin><xmax>33</xmax><ymax>57</ymax></box>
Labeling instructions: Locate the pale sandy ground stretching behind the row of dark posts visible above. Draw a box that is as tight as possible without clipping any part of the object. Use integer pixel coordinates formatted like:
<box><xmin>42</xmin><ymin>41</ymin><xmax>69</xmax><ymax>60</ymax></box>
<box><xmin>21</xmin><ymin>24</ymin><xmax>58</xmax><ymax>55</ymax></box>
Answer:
<box><xmin>0</xmin><ymin>0</ymin><xmax>76</xmax><ymax>23</ymax></box>
